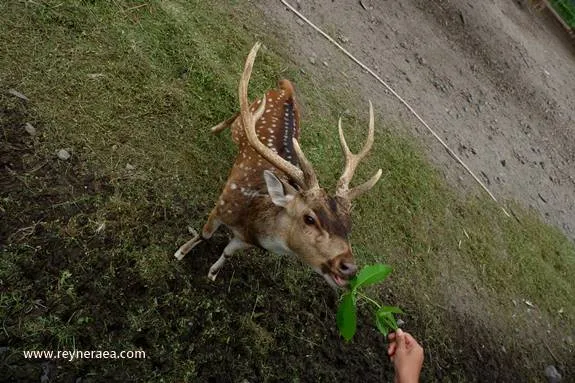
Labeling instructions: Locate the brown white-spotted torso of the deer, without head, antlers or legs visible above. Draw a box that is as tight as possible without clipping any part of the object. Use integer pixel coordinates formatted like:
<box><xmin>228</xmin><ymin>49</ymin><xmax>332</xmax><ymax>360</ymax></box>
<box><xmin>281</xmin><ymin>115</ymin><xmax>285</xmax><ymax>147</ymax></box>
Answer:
<box><xmin>212</xmin><ymin>80</ymin><xmax>299</xmax><ymax>245</ymax></box>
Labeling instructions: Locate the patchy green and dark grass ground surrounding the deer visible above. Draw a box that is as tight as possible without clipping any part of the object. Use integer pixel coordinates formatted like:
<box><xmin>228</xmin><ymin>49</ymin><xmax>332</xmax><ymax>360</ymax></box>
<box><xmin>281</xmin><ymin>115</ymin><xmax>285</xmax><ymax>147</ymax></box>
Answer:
<box><xmin>0</xmin><ymin>0</ymin><xmax>575</xmax><ymax>382</ymax></box>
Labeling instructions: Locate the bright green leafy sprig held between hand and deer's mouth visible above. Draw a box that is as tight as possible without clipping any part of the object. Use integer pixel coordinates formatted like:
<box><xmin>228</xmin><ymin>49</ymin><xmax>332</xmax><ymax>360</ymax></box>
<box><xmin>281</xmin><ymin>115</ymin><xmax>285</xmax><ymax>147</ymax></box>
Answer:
<box><xmin>336</xmin><ymin>264</ymin><xmax>403</xmax><ymax>341</ymax></box>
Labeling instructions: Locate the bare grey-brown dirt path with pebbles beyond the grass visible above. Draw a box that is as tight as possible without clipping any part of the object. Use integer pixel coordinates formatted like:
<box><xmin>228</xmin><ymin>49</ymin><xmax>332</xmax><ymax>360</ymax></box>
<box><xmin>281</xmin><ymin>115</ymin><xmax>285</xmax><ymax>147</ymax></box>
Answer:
<box><xmin>259</xmin><ymin>0</ymin><xmax>575</xmax><ymax>240</ymax></box>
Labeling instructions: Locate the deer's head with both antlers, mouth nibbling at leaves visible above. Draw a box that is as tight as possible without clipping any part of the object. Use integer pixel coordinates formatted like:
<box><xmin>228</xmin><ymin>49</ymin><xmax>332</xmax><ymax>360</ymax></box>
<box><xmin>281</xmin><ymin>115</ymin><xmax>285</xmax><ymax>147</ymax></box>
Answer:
<box><xmin>239</xmin><ymin>43</ymin><xmax>381</xmax><ymax>287</ymax></box>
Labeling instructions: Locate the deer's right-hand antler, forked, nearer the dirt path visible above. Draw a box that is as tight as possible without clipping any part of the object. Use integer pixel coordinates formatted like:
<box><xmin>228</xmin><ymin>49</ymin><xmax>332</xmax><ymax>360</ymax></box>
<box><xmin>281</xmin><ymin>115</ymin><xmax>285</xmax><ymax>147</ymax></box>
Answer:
<box><xmin>336</xmin><ymin>101</ymin><xmax>381</xmax><ymax>202</ymax></box>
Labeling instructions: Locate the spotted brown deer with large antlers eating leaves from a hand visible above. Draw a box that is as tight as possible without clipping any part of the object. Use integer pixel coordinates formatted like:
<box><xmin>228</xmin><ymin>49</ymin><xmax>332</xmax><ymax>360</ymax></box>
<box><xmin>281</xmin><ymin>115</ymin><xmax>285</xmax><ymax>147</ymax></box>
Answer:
<box><xmin>174</xmin><ymin>42</ymin><xmax>382</xmax><ymax>290</ymax></box>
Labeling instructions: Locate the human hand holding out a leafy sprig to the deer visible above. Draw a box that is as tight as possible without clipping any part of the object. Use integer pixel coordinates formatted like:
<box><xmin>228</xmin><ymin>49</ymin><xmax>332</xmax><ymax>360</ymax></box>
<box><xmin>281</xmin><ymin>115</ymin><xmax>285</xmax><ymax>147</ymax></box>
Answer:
<box><xmin>387</xmin><ymin>329</ymin><xmax>423</xmax><ymax>383</ymax></box>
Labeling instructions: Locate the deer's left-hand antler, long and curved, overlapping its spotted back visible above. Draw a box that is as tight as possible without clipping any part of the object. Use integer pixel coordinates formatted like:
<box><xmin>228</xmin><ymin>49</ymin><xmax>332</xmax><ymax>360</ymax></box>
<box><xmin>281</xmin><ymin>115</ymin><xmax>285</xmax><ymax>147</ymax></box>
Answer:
<box><xmin>238</xmin><ymin>42</ymin><xmax>308</xmax><ymax>189</ymax></box>
